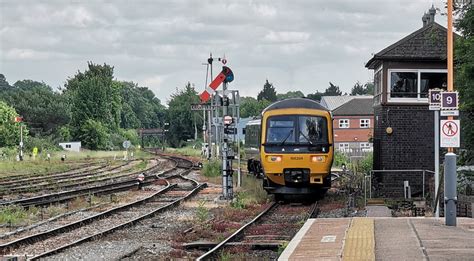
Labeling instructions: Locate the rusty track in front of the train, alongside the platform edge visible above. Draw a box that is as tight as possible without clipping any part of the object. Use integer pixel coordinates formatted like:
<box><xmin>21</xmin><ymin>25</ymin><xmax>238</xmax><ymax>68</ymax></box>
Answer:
<box><xmin>196</xmin><ymin>199</ymin><xmax>318</xmax><ymax>260</ymax></box>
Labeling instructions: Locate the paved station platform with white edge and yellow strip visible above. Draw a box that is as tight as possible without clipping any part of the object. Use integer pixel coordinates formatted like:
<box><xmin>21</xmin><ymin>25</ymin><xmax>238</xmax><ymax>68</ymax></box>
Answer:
<box><xmin>279</xmin><ymin>210</ymin><xmax>474</xmax><ymax>261</ymax></box>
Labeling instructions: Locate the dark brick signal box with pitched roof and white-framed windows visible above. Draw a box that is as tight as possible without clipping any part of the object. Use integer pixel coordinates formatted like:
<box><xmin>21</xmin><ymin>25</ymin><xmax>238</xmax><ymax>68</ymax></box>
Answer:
<box><xmin>366</xmin><ymin>7</ymin><xmax>447</xmax><ymax>196</ymax></box>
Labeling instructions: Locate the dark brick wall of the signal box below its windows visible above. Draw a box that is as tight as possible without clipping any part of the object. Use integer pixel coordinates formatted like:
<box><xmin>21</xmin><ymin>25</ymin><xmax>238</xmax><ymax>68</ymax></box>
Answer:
<box><xmin>374</xmin><ymin>105</ymin><xmax>434</xmax><ymax>197</ymax></box>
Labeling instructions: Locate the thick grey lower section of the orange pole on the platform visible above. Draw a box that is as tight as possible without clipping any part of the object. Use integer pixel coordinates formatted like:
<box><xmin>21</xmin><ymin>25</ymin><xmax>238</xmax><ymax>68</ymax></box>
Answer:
<box><xmin>444</xmin><ymin>152</ymin><xmax>457</xmax><ymax>226</ymax></box>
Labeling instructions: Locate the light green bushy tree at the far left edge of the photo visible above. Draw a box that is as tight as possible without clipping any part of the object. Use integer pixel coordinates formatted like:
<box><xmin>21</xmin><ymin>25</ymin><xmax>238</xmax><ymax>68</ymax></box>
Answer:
<box><xmin>0</xmin><ymin>101</ymin><xmax>28</xmax><ymax>147</ymax></box>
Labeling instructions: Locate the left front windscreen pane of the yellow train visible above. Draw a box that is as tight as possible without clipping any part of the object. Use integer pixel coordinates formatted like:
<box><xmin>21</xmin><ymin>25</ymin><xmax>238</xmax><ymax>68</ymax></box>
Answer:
<box><xmin>266</xmin><ymin>116</ymin><xmax>295</xmax><ymax>143</ymax></box>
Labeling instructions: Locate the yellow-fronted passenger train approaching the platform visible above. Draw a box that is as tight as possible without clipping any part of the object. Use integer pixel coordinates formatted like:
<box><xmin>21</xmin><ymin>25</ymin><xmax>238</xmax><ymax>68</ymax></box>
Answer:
<box><xmin>245</xmin><ymin>98</ymin><xmax>334</xmax><ymax>198</ymax></box>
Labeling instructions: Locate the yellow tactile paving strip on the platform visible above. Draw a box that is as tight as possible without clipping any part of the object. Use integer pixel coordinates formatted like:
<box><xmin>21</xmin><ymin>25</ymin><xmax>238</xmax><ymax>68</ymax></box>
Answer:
<box><xmin>342</xmin><ymin>218</ymin><xmax>375</xmax><ymax>260</ymax></box>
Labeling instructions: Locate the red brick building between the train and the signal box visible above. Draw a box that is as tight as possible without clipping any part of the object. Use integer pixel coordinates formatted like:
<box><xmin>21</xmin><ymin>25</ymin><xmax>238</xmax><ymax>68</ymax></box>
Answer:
<box><xmin>321</xmin><ymin>95</ymin><xmax>374</xmax><ymax>156</ymax></box>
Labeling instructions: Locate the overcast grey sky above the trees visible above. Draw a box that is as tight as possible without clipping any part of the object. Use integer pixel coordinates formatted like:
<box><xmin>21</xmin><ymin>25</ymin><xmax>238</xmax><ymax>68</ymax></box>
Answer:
<box><xmin>0</xmin><ymin>0</ymin><xmax>446</xmax><ymax>104</ymax></box>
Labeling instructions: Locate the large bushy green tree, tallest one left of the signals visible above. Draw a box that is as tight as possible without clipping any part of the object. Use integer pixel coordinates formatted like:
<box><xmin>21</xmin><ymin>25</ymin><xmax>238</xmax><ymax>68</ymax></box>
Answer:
<box><xmin>65</xmin><ymin>62</ymin><xmax>122</xmax><ymax>139</ymax></box>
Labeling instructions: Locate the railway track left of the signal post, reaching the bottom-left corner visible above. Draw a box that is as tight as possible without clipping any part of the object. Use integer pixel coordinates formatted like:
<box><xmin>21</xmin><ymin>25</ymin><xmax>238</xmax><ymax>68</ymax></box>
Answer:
<box><xmin>0</xmin><ymin>154</ymin><xmax>206</xmax><ymax>259</ymax></box>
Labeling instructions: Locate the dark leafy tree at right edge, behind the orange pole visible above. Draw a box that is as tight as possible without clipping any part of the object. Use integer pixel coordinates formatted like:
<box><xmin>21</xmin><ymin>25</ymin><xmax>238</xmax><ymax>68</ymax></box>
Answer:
<box><xmin>455</xmin><ymin>5</ymin><xmax>474</xmax><ymax>161</ymax></box>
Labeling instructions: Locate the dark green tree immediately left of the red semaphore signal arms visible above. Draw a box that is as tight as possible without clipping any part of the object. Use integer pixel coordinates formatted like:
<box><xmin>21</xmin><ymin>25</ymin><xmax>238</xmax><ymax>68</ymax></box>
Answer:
<box><xmin>168</xmin><ymin>82</ymin><xmax>202</xmax><ymax>147</ymax></box>
